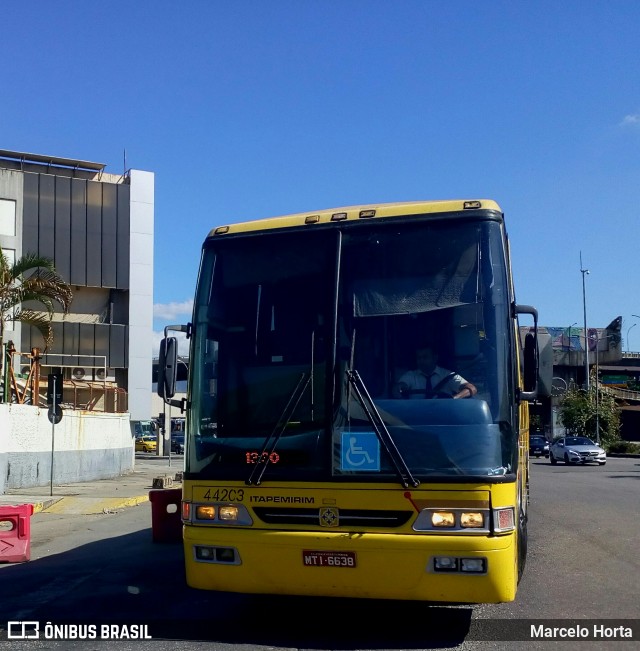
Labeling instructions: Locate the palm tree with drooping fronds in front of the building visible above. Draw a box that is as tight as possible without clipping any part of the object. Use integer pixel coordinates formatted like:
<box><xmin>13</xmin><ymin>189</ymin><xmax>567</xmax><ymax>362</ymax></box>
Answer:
<box><xmin>0</xmin><ymin>247</ymin><xmax>73</xmax><ymax>388</ymax></box>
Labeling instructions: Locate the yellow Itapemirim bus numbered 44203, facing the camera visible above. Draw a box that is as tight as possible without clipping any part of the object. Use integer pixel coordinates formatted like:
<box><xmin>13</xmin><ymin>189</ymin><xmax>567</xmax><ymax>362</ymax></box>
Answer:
<box><xmin>158</xmin><ymin>199</ymin><xmax>538</xmax><ymax>603</ymax></box>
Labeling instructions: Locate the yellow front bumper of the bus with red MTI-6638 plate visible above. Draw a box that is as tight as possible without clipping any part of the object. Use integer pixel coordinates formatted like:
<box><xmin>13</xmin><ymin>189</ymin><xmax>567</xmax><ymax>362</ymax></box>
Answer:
<box><xmin>184</xmin><ymin>526</ymin><xmax>517</xmax><ymax>603</ymax></box>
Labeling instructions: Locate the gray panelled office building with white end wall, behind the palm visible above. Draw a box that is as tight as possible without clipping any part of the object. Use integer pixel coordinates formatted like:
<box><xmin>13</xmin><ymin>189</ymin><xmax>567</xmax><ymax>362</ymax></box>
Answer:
<box><xmin>0</xmin><ymin>150</ymin><xmax>154</xmax><ymax>420</ymax></box>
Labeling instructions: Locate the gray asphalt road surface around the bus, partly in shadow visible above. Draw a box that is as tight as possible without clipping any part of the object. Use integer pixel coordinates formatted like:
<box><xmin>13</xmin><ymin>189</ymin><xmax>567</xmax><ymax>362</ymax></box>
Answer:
<box><xmin>0</xmin><ymin>458</ymin><xmax>640</xmax><ymax>651</ymax></box>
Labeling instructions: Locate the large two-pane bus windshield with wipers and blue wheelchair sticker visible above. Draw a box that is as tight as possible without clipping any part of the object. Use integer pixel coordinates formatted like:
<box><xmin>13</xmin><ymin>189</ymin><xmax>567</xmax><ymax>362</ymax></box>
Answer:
<box><xmin>185</xmin><ymin>218</ymin><xmax>517</xmax><ymax>483</ymax></box>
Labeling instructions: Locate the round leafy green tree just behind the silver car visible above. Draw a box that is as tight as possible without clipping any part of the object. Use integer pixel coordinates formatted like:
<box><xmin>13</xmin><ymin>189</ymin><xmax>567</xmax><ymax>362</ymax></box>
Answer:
<box><xmin>559</xmin><ymin>383</ymin><xmax>620</xmax><ymax>447</ymax></box>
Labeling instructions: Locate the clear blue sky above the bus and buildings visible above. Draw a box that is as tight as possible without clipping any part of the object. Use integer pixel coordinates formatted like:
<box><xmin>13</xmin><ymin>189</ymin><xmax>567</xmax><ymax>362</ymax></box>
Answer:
<box><xmin>5</xmin><ymin>0</ymin><xmax>640</xmax><ymax>351</ymax></box>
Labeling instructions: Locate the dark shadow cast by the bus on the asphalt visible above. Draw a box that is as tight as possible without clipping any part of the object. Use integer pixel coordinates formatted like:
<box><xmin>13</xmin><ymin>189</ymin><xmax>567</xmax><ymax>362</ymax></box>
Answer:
<box><xmin>0</xmin><ymin>529</ymin><xmax>472</xmax><ymax>651</ymax></box>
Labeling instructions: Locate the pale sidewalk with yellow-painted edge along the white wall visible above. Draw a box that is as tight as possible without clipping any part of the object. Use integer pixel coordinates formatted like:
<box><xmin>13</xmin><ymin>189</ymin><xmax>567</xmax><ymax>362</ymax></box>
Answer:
<box><xmin>0</xmin><ymin>457</ymin><xmax>182</xmax><ymax>515</ymax></box>
